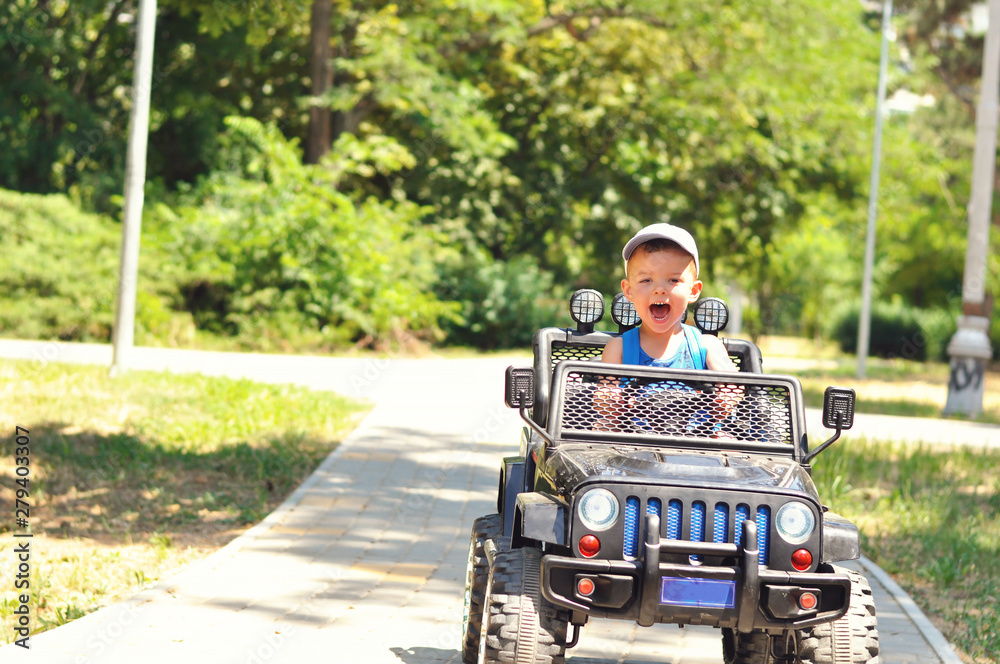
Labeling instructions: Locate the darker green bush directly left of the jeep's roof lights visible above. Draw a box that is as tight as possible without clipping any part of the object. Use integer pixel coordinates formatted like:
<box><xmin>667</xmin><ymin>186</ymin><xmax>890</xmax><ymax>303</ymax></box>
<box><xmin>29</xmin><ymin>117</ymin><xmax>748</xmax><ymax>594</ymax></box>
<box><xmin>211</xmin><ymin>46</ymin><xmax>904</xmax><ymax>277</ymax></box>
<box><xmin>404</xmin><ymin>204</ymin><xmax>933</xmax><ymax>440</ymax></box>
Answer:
<box><xmin>440</xmin><ymin>250</ymin><xmax>568</xmax><ymax>349</ymax></box>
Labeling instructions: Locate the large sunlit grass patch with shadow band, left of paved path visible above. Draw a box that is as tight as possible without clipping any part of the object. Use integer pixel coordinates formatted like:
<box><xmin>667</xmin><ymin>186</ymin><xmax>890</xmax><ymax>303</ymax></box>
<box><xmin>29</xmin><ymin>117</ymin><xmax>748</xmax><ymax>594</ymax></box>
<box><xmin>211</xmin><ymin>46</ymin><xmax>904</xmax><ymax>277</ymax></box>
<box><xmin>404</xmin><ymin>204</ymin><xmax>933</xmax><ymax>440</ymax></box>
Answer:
<box><xmin>0</xmin><ymin>361</ymin><xmax>363</xmax><ymax>643</ymax></box>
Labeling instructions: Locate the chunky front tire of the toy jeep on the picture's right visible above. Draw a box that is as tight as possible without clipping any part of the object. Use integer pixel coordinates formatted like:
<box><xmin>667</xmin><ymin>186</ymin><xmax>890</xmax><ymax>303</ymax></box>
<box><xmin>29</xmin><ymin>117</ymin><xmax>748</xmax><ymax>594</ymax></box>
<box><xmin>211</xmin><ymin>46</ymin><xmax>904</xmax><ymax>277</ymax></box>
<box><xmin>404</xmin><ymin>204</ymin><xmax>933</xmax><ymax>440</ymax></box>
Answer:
<box><xmin>798</xmin><ymin>567</ymin><xmax>879</xmax><ymax>664</ymax></box>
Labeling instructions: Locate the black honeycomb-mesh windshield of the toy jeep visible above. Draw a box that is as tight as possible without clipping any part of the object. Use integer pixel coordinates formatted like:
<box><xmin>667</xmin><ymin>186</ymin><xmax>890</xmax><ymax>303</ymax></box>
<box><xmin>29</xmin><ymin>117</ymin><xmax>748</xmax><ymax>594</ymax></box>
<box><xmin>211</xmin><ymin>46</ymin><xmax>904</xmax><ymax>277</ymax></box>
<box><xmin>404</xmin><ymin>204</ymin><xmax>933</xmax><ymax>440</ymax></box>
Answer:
<box><xmin>553</xmin><ymin>363</ymin><xmax>794</xmax><ymax>445</ymax></box>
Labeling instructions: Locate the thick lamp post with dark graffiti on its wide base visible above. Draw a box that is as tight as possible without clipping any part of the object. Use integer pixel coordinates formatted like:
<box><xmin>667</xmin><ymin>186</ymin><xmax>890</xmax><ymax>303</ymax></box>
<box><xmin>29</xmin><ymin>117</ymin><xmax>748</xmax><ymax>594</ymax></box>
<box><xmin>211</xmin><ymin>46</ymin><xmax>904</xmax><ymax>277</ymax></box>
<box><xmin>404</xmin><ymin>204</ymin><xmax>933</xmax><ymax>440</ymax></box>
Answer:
<box><xmin>944</xmin><ymin>0</ymin><xmax>1000</xmax><ymax>416</ymax></box>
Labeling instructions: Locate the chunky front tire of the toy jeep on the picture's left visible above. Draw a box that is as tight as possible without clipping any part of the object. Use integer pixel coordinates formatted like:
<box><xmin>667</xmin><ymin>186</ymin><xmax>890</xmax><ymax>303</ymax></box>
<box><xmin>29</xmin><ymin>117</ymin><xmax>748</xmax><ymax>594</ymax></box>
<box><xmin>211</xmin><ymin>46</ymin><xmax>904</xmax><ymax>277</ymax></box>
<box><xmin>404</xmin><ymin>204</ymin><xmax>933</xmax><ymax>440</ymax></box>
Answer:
<box><xmin>480</xmin><ymin>549</ymin><xmax>569</xmax><ymax>664</ymax></box>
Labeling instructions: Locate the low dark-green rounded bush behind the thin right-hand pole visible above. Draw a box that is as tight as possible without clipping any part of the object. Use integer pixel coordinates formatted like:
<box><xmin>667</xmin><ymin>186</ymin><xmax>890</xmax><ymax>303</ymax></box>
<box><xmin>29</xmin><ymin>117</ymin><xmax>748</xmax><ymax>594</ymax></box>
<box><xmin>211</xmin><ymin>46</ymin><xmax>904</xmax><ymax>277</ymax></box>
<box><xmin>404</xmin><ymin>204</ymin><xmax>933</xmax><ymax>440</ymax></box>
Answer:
<box><xmin>831</xmin><ymin>302</ymin><xmax>928</xmax><ymax>361</ymax></box>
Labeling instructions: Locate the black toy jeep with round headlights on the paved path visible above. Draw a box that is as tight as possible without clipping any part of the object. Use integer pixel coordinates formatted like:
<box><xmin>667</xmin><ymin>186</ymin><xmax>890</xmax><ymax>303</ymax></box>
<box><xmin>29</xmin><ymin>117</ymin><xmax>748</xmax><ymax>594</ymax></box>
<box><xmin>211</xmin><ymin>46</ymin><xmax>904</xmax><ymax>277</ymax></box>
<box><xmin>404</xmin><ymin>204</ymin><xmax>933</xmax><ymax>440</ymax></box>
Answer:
<box><xmin>462</xmin><ymin>290</ymin><xmax>879</xmax><ymax>664</ymax></box>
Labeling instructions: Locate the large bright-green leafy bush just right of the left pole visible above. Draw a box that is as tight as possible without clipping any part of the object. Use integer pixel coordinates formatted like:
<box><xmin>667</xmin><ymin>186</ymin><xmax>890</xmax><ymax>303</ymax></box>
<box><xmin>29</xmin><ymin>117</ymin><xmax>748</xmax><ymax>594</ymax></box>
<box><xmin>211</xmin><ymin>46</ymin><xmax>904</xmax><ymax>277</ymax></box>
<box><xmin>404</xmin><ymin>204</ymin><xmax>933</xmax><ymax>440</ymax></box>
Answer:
<box><xmin>157</xmin><ymin>118</ymin><xmax>457</xmax><ymax>350</ymax></box>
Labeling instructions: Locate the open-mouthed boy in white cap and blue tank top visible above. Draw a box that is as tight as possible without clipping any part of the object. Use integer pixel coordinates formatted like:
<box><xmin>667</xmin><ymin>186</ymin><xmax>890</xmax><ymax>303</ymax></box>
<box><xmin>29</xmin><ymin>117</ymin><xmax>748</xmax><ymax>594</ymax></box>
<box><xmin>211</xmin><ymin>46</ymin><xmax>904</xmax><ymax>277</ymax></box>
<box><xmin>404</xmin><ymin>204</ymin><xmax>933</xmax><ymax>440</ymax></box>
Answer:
<box><xmin>601</xmin><ymin>224</ymin><xmax>737</xmax><ymax>371</ymax></box>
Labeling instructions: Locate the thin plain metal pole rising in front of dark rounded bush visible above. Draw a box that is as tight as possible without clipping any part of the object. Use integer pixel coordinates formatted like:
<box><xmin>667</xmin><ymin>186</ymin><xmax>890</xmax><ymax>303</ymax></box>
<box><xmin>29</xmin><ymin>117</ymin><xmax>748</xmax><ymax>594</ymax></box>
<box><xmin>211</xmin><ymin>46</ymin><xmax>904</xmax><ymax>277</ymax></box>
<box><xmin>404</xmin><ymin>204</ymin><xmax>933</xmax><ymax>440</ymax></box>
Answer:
<box><xmin>858</xmin><ymin>0</ymin><xmax>892</xmax><ymax>378</ymax></box>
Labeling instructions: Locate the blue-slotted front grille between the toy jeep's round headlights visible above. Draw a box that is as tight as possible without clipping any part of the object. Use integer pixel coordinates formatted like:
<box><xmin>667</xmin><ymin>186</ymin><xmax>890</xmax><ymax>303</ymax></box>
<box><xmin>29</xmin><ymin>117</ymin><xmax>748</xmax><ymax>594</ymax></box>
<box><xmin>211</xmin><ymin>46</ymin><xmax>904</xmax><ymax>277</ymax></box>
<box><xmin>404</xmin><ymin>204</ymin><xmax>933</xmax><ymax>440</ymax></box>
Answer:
<box><xmin>622</xmin><ymin>496</ymin><xmax>771</xmax><ymax>565</ymax></box>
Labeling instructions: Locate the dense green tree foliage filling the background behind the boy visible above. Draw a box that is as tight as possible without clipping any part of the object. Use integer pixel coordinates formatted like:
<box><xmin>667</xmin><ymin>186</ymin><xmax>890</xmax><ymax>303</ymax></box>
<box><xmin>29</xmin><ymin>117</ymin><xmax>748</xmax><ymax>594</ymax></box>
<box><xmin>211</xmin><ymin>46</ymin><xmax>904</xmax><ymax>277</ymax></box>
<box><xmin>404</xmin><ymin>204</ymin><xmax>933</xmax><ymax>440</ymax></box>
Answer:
<box><xmin>0</xmin><ymin>0</ymin><xmax>981</xmax><ymax>345</ymax></box>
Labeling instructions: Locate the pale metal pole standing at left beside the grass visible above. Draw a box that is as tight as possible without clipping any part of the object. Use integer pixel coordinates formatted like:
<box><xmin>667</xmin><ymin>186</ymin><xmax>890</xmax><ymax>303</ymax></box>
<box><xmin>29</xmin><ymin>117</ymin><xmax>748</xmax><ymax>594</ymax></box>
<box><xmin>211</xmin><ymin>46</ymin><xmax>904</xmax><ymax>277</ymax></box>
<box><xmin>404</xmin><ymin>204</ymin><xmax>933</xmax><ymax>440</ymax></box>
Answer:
<box><xmin>111</xmin><ymin>0</ymin><xmax>156</xmax><ymax>375</ymax></box>
